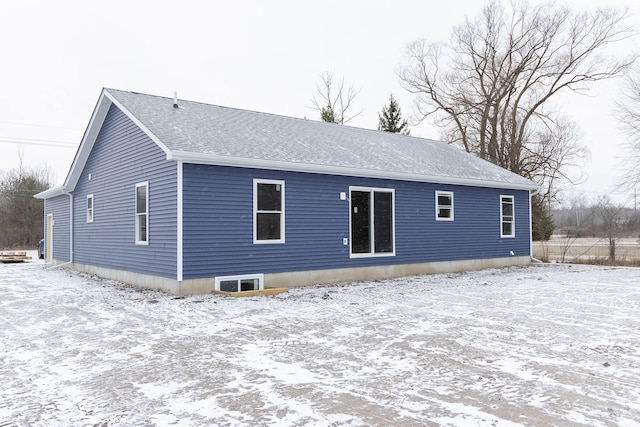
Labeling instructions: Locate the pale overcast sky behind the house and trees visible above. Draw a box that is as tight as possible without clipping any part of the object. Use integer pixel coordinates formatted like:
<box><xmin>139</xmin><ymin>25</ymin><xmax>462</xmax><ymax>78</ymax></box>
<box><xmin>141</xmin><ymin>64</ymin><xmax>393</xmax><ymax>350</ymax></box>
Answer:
<box><xmin>0</xmin><ymin>0</ymin><xmax>640</xmax><ymax>207</ymax></box>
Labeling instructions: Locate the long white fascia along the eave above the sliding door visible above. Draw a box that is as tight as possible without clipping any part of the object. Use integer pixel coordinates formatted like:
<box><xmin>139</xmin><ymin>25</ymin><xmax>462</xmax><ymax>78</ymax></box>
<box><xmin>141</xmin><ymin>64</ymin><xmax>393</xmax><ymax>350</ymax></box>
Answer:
<box><xmin>167</xmin><ymin>151</ymin><xmax>539</xmax><ymax>190</ymax></box>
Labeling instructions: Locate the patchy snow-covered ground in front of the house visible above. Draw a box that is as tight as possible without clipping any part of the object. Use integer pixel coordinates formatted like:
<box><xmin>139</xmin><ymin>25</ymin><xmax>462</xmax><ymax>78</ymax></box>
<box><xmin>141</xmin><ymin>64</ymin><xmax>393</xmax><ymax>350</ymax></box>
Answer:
<box><xmin>0</xmin><ymin>260</ymin><xmax>640</xmax><ymax>427</ymax></box>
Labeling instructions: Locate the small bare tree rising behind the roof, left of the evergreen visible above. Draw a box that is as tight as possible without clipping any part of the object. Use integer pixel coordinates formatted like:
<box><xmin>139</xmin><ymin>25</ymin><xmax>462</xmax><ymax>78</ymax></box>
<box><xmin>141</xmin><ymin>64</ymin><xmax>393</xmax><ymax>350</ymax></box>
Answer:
<box><xmin>312</xmin><ymin>72</ymin><xmax>362</xmax><ymax>125</ymax></box>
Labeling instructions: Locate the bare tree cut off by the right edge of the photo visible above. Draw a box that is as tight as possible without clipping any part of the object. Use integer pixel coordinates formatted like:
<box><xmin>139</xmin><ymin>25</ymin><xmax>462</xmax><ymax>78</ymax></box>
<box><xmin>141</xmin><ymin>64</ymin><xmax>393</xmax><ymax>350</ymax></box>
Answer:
<box><xmin>614</xmin><ymin>67</ymin><xmax>640</xmax><ymax>192</ymax></box>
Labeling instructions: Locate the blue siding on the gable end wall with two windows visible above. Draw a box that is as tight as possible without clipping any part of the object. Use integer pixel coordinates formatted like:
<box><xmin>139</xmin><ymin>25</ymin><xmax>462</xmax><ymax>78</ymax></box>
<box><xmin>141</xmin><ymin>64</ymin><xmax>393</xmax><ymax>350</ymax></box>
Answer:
<box><xmin>74</xmin><ymin>105</ymin><xmax>177</xmax><ymax>279</ymax></box>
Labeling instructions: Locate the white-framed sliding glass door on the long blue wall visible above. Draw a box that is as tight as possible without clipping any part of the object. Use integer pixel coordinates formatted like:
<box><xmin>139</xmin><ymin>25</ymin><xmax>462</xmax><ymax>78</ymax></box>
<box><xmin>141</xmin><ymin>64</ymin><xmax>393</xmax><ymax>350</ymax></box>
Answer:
<box><xmin>350</xmin><ymin>188</ymin><xmax>395</xmax><ymax>257</ymax></box>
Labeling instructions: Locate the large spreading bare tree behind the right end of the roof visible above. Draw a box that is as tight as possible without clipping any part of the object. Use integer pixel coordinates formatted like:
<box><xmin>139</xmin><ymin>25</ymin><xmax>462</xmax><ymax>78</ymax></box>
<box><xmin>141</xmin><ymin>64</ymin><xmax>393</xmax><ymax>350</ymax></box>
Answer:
<box><xmin>399</xmin><ymin>1</ymin><xmax>635</xmax><ymax>199</ymax></box>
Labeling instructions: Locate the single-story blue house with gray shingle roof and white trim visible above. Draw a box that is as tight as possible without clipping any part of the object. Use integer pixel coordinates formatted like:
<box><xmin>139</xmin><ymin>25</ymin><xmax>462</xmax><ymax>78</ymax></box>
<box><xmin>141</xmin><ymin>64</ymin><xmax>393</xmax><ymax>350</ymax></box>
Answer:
<box><xmin>36</xmin><ymin>89</ymin><xmax>537</xmax><ymax>294</ymax></box>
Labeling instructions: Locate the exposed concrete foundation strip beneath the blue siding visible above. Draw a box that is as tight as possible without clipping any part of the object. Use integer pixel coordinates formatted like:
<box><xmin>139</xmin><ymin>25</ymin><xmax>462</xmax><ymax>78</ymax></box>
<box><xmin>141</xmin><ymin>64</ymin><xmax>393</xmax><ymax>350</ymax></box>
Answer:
<box><xmin>54</xmin><ymin>256</ymin><xmax>531</xmax><ymax>295</ymax></box>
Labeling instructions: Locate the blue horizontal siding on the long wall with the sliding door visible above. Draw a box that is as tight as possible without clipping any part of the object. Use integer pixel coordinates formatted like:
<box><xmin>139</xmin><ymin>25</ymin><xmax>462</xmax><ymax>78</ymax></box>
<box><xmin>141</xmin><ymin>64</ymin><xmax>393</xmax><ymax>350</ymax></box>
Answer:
<box><xmin>183</xmin><ymin>164</ymin><xmax>530</xmax><ymax>279</ymax></box>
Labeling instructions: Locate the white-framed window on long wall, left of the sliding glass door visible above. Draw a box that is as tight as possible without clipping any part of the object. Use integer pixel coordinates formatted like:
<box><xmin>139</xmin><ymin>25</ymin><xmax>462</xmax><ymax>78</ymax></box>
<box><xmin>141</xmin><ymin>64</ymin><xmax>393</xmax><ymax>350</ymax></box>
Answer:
<box><xmin>253</xmin><ymin>179</ymin><xmax>284</xmax><ymax>243</ymax></box>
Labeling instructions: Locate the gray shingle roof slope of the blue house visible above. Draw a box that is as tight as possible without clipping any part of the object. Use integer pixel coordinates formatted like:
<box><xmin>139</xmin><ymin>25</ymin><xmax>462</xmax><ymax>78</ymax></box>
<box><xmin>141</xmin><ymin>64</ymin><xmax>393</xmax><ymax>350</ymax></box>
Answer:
<box><xmin>105</xmin><ymin>89</ymin><xmax>537</xmax><ymax>189</ymax></box>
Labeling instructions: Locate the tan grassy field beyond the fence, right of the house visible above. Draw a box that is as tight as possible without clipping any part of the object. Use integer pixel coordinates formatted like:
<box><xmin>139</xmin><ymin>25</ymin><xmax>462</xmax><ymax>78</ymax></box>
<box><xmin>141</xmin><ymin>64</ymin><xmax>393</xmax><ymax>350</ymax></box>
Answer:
<box><xmin>533</xmin><ymin>235</ymin><xmax>640</xmax><ymax>266</ymax></box>
